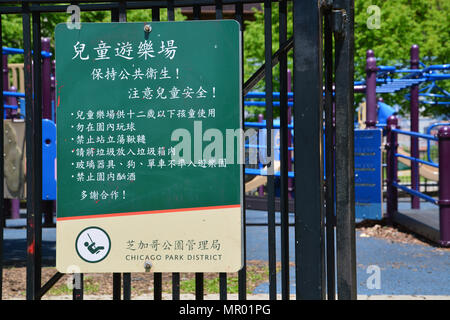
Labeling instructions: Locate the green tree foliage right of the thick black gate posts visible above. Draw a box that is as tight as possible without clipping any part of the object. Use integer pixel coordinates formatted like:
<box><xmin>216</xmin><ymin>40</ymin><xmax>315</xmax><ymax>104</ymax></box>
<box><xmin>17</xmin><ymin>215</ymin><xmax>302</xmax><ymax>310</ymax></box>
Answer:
<box><xmin>355</xmin><ymin>0</ymin><xmax>450</xmax><ymax>116</ymax></box>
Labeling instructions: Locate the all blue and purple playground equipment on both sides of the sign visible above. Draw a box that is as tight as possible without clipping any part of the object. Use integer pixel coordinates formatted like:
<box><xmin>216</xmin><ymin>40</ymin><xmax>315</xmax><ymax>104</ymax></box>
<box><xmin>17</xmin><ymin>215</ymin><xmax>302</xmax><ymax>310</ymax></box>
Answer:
<box><xmin>3</xmin><ymin>39</ymin><xmax>450</xmax><ymax>242</ymax></box>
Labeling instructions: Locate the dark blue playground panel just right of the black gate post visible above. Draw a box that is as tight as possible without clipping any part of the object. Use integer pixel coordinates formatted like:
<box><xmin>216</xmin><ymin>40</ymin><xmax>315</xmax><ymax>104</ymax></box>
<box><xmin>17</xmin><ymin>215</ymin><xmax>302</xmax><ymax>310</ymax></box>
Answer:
<box><xmin>355</xmin><ymin>129</ymin><xmax>383</xmax><ymax>220</ymax></box>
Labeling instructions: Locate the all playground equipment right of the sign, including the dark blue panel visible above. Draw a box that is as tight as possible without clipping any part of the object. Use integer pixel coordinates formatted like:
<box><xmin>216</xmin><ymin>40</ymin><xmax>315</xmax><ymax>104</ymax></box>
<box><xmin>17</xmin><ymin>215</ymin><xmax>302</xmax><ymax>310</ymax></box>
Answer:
<box><xmin>245</xmin><ymin>45</ymin><xmax>450</xmax><ymax>246</ymax></box>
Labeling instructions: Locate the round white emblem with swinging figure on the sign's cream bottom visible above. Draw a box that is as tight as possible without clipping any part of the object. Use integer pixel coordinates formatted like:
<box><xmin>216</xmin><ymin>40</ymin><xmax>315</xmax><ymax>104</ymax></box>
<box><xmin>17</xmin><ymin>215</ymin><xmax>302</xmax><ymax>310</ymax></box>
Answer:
<box><xmin>75</xmin><ymin>227</ymin><xmax>111</xmax><ymax>263</ymax></box>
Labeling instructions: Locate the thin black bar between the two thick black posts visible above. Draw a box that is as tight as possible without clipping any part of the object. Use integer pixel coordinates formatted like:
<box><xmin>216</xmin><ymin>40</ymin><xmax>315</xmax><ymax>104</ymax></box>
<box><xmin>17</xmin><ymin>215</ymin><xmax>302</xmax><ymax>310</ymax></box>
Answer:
<box><xmin>324</xmin><ymin>12</ymin><xmax>336</xmax><ymax>300</ymax></box>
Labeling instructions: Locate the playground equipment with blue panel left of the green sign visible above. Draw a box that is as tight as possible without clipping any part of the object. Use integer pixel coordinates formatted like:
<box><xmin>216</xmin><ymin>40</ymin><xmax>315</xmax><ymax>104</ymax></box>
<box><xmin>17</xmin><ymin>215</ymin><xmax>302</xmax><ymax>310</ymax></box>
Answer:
<box><xmin>2</xmin><ymin>38</ymin><xmax>56</xmax><ymax>226</ymax></box>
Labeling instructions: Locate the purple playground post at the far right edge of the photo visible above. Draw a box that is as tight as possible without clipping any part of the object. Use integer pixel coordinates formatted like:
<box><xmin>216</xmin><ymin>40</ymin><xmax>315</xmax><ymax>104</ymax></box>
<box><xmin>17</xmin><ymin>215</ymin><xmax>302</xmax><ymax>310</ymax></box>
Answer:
<box><xmin>438</xmin><ymin>126</ymin><xmax>450</xmax><ymax>247</ymax></box>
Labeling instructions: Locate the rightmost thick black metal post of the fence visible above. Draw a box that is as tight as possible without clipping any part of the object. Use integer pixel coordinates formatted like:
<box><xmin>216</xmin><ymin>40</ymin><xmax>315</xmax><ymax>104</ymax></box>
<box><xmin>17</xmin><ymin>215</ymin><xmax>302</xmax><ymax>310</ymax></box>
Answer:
<box><xmin>334</xmin><ymin>0</ymin><xmax>356</xmax><ymax>300</ymax></box>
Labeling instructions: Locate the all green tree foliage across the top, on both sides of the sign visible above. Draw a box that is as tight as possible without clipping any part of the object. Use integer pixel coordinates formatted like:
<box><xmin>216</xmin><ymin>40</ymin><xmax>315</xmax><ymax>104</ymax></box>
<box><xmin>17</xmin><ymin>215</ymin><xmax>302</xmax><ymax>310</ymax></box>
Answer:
<box><xmin>2</xmin><ymin>0</ymin><xmax>450</xmax><ymax>115</ymax></box>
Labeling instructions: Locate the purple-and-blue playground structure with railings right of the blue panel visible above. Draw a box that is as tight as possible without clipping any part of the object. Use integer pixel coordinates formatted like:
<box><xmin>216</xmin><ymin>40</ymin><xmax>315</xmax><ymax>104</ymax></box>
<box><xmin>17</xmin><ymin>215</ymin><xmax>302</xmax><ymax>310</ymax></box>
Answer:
<box><xmin>362</xmin><ymin>45</ymin><xmax>450</xmax><ymax>246</ymax></box>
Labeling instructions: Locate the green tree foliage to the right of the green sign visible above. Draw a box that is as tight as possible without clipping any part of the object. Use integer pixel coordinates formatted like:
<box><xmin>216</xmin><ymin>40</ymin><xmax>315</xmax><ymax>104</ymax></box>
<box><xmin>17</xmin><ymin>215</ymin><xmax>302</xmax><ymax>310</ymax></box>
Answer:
<box><xmin>244</xmin><ymin>0</ymin><xmax>450</xmax><ymax>115</ymax></box>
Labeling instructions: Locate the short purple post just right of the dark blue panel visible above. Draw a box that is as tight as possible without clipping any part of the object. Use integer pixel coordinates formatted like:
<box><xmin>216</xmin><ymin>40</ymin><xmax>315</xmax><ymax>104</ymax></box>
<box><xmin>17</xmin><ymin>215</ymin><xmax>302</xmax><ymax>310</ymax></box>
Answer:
<box><xmin>386</xmin><ymin>115</ymin><xmax>398</xmax><ymax>223</ymax></box>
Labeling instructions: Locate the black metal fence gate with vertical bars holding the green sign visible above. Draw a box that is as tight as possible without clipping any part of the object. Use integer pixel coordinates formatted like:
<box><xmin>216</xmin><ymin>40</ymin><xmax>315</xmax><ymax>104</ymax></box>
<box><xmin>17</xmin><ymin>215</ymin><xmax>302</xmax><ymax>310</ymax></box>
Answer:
<box><xmin>0</xmin><ymin>0</ymin><xmax>356</xmax><ymax>300</ymax></box>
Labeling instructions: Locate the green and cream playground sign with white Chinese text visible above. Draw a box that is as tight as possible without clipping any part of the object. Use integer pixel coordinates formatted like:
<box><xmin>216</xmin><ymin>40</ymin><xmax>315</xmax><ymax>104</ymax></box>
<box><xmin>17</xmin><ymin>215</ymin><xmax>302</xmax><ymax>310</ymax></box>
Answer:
<box><xmin>55</xmin><ymin>20</ymin><xmax>242</xmax><ymax>272</ymax></box>
